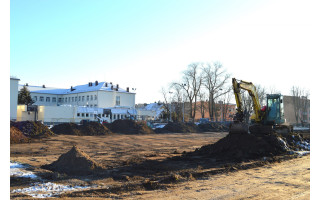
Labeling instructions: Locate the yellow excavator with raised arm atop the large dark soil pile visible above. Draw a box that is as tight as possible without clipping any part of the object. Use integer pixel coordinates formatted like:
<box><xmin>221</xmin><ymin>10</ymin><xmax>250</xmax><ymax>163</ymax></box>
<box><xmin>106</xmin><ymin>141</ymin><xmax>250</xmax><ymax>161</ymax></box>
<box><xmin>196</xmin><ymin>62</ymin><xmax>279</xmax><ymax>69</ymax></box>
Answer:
<box><xmin>230</xmin><ymin>78</ymin><xmax>292</xmax><ymax>135</ymax></box>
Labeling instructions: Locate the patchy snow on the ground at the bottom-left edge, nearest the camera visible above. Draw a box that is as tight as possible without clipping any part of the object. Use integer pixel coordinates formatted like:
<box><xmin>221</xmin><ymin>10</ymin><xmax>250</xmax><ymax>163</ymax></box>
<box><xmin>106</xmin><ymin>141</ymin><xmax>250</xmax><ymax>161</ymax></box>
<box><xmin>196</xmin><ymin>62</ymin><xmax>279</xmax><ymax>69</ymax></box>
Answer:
<box><xmin>11</xmin><ymin>182</ymin><xmax>96</xmax><ymax>198</ymax></box>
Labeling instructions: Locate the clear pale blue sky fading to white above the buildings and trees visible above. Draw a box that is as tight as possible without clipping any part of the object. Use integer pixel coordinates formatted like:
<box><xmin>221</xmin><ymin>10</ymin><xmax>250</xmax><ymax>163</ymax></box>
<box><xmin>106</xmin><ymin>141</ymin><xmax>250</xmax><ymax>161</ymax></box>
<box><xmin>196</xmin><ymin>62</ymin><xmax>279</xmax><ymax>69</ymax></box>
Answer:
<box><xmin>10</xmin><ymin>0</ymin><xmax>319</xmax><ymax>103</ymax></box>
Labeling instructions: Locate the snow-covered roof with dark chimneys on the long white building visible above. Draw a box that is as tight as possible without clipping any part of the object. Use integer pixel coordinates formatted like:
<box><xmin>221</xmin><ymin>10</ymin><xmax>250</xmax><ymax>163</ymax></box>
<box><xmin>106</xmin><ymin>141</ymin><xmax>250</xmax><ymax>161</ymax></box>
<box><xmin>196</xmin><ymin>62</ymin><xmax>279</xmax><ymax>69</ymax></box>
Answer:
<box><xmin>19</xmin><ymin>82</ymin><xmax>134</xmax><ymax>95</ymax></box>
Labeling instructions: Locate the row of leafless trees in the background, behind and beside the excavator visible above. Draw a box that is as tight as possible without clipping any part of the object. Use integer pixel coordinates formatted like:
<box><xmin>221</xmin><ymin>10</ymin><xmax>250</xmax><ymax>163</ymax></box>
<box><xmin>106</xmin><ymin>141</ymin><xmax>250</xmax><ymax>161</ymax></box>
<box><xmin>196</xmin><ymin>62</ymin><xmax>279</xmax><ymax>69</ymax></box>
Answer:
<box><xmin>161</xmin><ymin>62</ymin><xmax>310</xmax><ymax>123</ymax></box>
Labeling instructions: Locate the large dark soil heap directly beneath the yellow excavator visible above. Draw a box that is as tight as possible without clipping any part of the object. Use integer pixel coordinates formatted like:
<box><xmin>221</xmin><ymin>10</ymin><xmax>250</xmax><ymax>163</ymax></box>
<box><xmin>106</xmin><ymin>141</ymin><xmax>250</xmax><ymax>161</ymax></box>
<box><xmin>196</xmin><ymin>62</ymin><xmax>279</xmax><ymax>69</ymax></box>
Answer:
<box><xmin>193</xmin><ymin>133</ymin><xmax>289</xmax><ymax>161</ymax></box>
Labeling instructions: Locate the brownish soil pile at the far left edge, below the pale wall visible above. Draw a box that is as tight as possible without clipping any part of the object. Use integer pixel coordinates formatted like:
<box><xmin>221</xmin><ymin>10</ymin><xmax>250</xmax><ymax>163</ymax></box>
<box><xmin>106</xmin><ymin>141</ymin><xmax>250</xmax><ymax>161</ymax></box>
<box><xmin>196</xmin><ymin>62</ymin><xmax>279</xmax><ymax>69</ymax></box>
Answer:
<box><xmin>10</xmin><ymin>121</ymin><xmax>54</xmax><ymax>138</ymax></box>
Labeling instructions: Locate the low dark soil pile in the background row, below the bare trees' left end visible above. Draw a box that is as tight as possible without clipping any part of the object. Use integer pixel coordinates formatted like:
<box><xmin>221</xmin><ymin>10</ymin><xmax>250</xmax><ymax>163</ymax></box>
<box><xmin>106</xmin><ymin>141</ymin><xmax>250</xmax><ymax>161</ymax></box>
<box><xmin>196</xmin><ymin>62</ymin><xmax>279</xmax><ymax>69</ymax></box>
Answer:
<box><xmin>155</xmin><ymin>122</ymin><xmax>200</xmax><ymax>133</ymax></box>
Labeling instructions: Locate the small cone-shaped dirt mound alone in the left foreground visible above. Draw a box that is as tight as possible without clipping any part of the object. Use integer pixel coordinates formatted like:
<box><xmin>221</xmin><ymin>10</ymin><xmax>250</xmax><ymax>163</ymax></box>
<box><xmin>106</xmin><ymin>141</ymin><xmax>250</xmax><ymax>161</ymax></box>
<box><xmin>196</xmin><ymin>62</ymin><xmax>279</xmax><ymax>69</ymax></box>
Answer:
<box><xmin>42</xmin><ymin>146</ymin><xmax>104</xmax><ymax>176</ymax></box>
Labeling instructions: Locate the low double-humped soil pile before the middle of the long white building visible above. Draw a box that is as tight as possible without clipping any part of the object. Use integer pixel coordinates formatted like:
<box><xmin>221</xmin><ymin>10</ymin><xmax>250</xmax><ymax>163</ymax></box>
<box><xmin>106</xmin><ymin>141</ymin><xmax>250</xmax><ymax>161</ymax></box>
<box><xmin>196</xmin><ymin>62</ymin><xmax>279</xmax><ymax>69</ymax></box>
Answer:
<box><xmin>51</xmin><ymin>122</ymin><xmax>112</xmax><ymax>135</ymax></box>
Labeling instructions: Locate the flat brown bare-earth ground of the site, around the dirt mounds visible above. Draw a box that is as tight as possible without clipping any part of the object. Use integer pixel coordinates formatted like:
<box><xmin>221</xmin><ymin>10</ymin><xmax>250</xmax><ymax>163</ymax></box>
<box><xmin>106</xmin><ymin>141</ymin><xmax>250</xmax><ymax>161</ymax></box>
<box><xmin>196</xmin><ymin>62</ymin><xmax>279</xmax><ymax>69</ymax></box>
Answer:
<box><xmin>10</xmin><ymin>132</ymin><xmax>310</xmax><ymax>199</ymax></box>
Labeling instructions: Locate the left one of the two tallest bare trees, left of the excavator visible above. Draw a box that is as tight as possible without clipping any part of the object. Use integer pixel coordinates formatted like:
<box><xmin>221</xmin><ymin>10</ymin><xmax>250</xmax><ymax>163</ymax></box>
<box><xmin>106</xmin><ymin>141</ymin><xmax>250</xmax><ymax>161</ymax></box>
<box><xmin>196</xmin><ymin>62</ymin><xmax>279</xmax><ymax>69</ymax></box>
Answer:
<box><xmin>172</xmin><ymin>63</ymin><xmax>203</xmax><ymax>120</ymax></box>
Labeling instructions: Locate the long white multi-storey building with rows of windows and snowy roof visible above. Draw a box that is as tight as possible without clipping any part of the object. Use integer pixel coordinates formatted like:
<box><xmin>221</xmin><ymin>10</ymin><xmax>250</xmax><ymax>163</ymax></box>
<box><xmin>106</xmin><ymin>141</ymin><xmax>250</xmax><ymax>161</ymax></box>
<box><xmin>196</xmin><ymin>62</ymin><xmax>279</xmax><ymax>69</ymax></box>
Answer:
<box><xmin>17</xmin><ymin>81</ymin><xmax>137</xmax><ymax>123</ymax></box>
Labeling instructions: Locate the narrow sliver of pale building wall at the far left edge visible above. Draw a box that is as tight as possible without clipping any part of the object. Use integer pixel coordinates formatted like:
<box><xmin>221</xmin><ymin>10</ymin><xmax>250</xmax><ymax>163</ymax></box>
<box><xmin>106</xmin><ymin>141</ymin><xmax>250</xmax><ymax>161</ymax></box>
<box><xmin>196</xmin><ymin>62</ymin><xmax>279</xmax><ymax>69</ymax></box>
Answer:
<box><xmin>10</xmin><ymin>77</ymin><xmax>20</xmax><ymax>120</ymax></box>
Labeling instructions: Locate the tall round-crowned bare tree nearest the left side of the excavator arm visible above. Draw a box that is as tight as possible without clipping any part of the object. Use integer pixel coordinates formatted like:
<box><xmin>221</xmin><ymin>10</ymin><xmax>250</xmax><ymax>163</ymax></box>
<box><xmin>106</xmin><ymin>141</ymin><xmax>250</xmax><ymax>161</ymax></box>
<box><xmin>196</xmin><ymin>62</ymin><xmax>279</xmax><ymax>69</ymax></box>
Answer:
<box><xmin>203</xmin><ymin>62</ymin><xmax>230</xmax><ymax>120</ymax></box>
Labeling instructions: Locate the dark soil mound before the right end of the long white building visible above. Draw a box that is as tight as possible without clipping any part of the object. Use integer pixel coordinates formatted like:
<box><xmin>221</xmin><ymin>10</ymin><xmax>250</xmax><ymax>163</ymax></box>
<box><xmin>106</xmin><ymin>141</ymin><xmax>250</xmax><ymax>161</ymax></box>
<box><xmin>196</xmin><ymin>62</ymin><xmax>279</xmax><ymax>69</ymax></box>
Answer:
<box><xmin>107</xmin><ymin>119</ymin><xmax>154</xmax><ymax>134</ymax></box>
